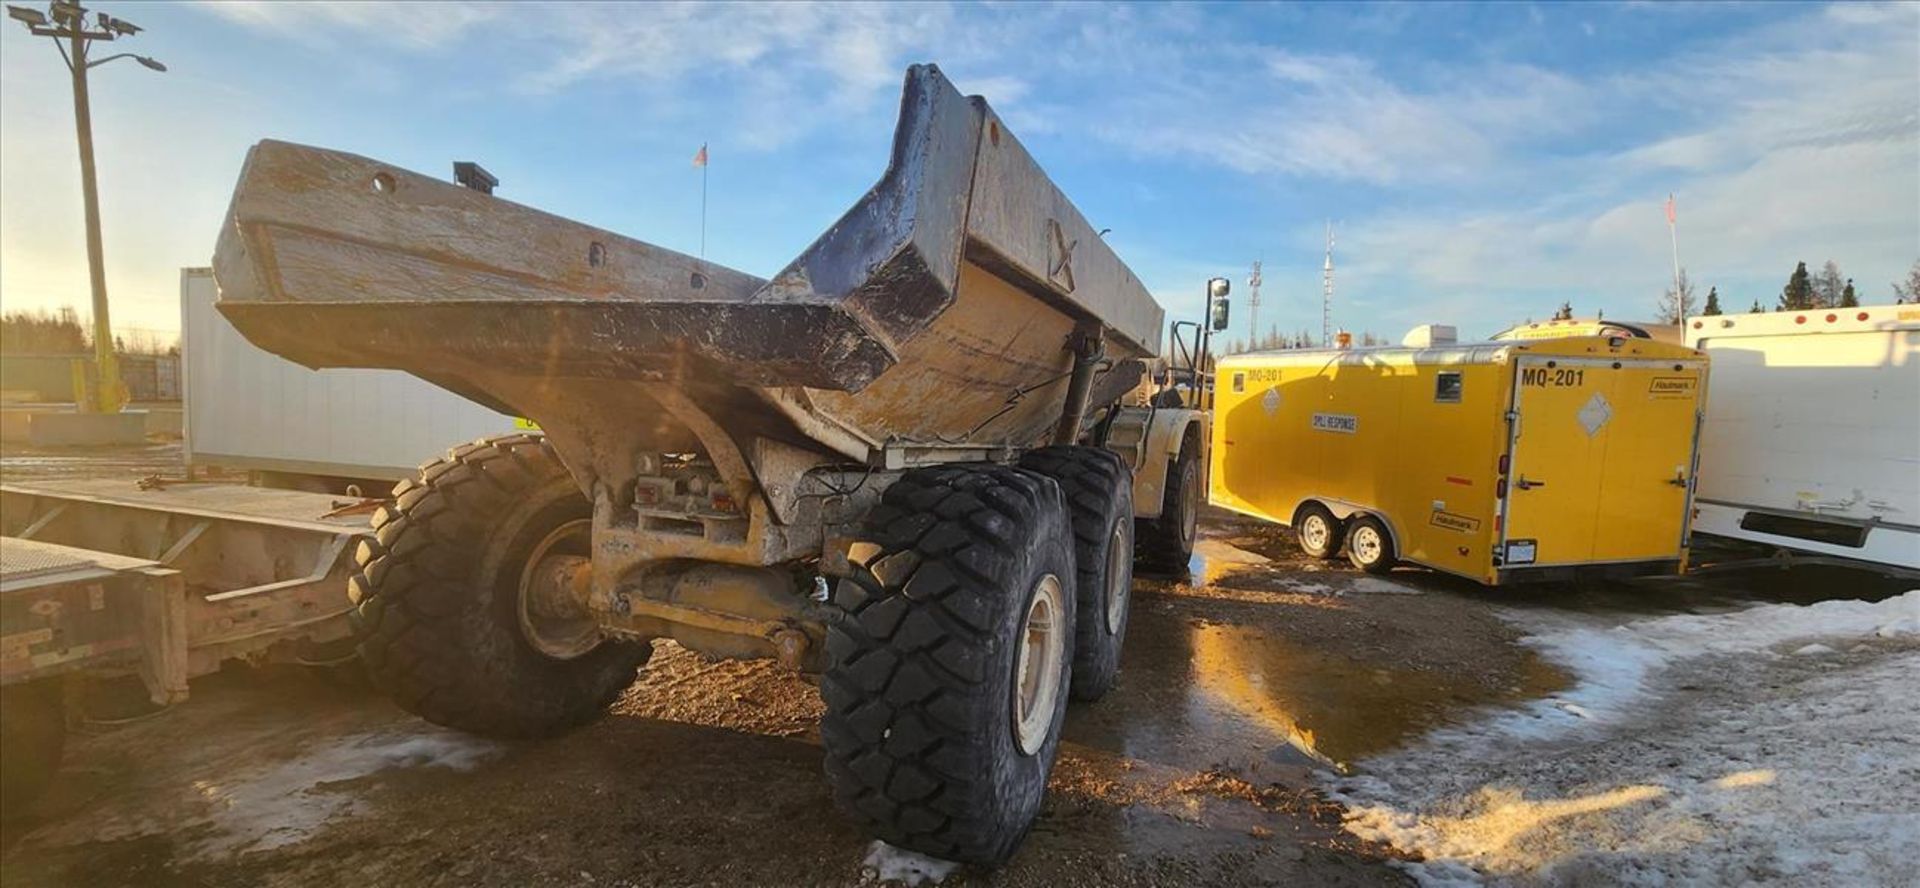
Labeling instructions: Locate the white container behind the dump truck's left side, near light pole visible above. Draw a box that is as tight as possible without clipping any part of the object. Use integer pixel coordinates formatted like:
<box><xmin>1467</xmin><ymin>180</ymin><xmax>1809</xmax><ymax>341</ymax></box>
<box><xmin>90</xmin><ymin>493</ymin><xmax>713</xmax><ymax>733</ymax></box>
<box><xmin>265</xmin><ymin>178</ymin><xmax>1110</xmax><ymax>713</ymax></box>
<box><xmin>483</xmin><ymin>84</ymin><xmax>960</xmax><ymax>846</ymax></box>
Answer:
<box><xmin>180</xmin><ymin>269</ymin><xmax>515</xmax><ymax>479</ymax></box>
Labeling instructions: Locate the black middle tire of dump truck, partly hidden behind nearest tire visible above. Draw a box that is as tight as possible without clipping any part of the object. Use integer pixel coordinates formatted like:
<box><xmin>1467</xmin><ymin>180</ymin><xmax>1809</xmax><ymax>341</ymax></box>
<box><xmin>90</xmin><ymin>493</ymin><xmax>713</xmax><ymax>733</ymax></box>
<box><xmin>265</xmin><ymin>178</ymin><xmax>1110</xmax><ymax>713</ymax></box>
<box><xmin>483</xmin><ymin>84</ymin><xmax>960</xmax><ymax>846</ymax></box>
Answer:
<box><xmin>1020</xmin><ymin>447</ymin><xmax>1133</xmax><ymax>702</ymax></box>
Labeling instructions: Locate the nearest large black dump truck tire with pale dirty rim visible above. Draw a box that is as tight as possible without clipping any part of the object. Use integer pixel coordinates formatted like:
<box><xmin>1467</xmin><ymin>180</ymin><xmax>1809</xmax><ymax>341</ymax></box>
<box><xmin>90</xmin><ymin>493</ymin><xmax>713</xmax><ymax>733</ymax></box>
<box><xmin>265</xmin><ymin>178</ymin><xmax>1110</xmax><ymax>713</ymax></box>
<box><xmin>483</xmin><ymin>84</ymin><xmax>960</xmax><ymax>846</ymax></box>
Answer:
<box><xmin>820</xmin><ymin>466</ymin><xmax>1073</xmax><ymax>867</ymax></box>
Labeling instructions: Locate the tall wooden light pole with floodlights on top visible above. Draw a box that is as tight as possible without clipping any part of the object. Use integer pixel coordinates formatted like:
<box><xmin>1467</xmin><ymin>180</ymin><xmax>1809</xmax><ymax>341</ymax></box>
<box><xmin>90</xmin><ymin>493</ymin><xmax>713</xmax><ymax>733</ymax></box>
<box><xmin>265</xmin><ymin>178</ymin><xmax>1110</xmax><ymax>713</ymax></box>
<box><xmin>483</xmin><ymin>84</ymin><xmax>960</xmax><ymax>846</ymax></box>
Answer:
<box><xmin>6</xmin><ymin>0</ymin><xmax>167</xmax><ymax>412</ymax></box>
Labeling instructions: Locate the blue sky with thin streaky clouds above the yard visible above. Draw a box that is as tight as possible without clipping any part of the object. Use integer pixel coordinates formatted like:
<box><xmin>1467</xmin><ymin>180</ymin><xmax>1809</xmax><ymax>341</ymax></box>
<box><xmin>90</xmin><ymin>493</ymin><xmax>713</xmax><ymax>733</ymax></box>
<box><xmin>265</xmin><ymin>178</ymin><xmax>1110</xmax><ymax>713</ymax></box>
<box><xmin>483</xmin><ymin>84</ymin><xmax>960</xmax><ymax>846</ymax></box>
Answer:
<box><xmin>0</xmin><ymin>2</ymin><xmax>1920</xmax><ymax>347</ymax></box>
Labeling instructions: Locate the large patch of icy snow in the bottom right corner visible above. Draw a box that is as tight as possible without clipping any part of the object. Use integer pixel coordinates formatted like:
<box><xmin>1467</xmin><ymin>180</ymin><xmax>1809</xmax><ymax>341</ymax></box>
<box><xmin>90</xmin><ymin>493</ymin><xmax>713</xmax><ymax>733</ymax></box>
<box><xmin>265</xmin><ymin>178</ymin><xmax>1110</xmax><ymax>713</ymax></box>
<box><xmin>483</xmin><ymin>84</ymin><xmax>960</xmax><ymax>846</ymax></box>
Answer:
<box><xmin>1332</xmin><ymin>591</ymin><xmax>1920</xmax><ymax>886</ymax></box>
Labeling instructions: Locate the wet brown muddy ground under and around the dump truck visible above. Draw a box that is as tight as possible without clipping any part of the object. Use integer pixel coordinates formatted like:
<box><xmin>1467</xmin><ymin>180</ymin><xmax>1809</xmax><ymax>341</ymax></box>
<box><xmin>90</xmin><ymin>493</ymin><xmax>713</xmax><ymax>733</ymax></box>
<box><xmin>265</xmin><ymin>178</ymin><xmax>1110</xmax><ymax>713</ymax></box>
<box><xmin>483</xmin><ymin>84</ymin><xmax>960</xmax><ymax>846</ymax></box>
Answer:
<box><xmin>0</xmin><ymin>448</ymin><xmax>1889</xmax><ymax>886</ymax></box>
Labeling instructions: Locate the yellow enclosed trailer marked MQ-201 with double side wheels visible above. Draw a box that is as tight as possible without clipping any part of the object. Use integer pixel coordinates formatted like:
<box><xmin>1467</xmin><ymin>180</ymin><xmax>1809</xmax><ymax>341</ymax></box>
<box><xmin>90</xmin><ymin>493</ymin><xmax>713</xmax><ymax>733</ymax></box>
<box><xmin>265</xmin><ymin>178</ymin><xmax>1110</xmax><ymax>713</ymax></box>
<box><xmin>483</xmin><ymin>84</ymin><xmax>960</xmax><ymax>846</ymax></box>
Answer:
<box><xmin>1210</xmin><ymin>336</ymin><xmax>1707</xmax><ymax>585</ymax></box>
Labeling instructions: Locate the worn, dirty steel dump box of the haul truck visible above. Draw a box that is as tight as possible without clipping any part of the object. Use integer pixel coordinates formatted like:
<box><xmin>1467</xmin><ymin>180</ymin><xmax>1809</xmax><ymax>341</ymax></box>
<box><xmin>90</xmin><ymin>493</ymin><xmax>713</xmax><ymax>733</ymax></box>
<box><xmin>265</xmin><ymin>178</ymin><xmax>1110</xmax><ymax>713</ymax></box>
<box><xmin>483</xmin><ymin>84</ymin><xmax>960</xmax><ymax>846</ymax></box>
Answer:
<box><xmin>215</xmin><ymin>65</ymin><xmax>1164</xmax><ymax>498</ymax></box>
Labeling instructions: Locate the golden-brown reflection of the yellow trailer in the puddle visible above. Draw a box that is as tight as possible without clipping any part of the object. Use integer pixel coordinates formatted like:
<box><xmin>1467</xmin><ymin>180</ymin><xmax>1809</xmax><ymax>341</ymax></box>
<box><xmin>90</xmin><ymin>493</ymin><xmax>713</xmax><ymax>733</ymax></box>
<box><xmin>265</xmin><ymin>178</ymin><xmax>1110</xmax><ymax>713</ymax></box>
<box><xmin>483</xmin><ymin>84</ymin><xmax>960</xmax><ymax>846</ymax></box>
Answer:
<box><xmin>1188</xmin><ymin>623</ymin><xmax>1559</xmax><ymax>773</ymax></box>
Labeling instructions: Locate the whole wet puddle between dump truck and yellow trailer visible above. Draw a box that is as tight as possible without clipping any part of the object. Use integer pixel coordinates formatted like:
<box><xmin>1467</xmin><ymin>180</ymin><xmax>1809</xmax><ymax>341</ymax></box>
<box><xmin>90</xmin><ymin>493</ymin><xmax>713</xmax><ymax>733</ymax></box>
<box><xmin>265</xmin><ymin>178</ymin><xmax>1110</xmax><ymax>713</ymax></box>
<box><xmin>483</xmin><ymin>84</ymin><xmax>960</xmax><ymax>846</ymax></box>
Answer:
<box><xmin>1069</xmin><ymin>539</ymin><xmax>1567</xmax><ymax>773</ymax></box>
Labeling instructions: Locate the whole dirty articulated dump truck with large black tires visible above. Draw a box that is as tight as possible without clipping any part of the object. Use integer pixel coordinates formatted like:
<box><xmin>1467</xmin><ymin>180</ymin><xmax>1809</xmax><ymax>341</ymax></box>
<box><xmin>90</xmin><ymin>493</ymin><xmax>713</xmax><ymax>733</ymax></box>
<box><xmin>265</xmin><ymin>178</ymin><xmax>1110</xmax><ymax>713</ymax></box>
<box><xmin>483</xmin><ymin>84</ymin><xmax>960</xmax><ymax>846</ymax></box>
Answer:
<box><xmin>213</xmin><ymin>65</ymin><xmax>1206</xmax><ymax>865</ymax></box>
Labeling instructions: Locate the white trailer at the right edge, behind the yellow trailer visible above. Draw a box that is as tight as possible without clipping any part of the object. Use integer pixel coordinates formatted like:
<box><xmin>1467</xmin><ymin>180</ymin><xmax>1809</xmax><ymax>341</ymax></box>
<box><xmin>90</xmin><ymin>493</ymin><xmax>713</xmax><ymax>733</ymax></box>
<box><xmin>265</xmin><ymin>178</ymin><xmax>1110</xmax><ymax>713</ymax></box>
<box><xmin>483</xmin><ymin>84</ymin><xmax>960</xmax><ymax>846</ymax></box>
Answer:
<box><xmin>1686</xmin><ymin>305</ymin><xmax>1920</xmax><ymax>570</ymax></box>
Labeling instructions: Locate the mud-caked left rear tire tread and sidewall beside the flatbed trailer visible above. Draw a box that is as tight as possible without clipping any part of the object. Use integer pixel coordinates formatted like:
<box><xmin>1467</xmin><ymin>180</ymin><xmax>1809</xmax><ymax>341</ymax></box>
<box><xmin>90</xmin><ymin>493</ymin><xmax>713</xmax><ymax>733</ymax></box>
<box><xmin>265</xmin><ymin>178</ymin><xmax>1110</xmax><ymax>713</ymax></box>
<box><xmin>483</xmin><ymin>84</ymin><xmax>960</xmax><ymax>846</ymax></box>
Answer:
<box><xmin>348</xmin><ymin>435</ymin><xmax>651</xmax><ymax>736</ymax></box>
